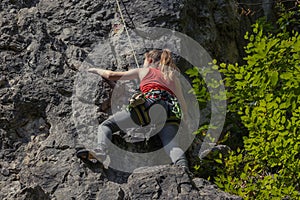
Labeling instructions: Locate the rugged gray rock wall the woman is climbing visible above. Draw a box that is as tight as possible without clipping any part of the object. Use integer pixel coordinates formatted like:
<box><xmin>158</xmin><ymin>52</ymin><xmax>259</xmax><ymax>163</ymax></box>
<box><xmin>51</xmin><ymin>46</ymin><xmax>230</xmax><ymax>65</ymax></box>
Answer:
<box><xmin>0</xmin><ymin>0</ymin><xmax>244</xmax><ymax>200</ymax></box>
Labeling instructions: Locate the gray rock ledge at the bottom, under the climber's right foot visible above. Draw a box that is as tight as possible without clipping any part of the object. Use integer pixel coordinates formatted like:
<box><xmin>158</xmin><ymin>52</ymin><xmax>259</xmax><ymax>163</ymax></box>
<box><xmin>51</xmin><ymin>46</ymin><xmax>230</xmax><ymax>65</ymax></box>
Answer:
<box><xmin>127</xmin><ymin>166</ymin><xmax>241</xmax><ymax>200</ymax></box>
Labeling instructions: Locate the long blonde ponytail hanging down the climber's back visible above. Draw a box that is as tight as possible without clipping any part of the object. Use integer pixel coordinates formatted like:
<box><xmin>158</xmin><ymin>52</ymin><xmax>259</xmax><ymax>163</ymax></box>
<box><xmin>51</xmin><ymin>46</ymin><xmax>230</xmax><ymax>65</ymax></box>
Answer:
<box><xmin>159</xmin><ymin>49</ymin><xmax>179</xmax><ymax>80</ymax></box>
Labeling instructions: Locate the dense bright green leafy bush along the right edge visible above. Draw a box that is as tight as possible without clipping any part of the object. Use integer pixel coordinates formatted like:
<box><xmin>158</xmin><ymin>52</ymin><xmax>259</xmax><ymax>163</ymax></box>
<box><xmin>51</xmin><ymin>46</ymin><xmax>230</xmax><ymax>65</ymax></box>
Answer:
<box><xmin>190</xmin><ymin>5</ymin><xmax>300</xmax><ymax>199</ymax></box>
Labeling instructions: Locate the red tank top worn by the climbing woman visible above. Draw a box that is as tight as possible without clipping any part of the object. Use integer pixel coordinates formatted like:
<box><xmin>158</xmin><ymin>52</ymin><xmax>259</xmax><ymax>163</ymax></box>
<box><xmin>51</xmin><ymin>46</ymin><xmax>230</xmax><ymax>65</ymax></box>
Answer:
<box><xmin>140</xmin><ymin>67</ymin><xmax>175</xmax><ymax>94</ymax></box>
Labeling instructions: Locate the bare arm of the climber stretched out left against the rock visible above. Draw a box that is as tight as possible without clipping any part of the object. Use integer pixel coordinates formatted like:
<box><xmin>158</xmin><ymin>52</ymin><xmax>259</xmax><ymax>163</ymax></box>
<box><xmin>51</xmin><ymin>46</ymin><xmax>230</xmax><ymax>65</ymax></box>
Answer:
<box><xmin>87</xmin><ymin>68</ymin><xmax>139</xmax><ymax>81</ymax></box>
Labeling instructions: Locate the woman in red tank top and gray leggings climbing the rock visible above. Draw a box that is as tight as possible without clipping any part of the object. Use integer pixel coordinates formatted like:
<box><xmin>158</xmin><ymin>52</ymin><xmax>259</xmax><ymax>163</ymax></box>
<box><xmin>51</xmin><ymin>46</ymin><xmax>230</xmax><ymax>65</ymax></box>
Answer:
<box><xmin>77</xmin><ymin>49</ymin><xmax>188</xmax><ymax>169</ymax></box>
